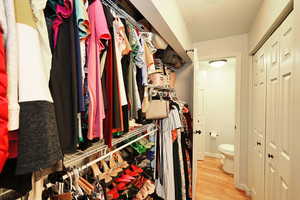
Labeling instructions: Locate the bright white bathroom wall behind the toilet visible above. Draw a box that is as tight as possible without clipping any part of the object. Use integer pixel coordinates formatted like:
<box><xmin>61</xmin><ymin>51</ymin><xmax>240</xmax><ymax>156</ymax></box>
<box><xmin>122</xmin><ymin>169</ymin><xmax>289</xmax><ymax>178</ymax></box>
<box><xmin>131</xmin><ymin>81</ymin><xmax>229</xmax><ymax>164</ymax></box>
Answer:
<box><xmin>198</xmin><ymin>58</ymin><xmax>236</xmax><ymax>153</ymax></box>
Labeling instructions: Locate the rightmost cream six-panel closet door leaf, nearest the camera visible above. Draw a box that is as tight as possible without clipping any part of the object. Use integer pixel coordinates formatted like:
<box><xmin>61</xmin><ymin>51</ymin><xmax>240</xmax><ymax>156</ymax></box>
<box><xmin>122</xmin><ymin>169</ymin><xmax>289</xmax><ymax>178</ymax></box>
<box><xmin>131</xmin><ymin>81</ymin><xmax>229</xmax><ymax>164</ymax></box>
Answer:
<box><xmin>278</xmin><ymin>13</ymin><xmax>294</xmax><ymax>200</ymax></box>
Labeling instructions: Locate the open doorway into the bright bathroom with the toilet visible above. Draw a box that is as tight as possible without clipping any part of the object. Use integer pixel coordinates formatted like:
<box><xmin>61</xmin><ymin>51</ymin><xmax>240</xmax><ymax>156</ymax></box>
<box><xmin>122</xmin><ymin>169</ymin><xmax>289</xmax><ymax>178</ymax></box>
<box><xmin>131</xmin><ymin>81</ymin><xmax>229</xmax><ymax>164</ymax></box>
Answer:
<box><xmin>194</xmin><ymin>54</ymin><xmax>246</xmax><ymax>200</ymax></box>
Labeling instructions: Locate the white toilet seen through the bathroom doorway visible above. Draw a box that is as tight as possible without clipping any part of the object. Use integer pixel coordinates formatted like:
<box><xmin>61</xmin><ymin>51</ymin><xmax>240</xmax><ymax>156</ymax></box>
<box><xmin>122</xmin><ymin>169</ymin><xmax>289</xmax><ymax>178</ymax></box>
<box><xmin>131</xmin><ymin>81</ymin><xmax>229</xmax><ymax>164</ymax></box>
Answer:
<box><xmin>218</xmin><ymin>144</ymin><xmax>234</xmax><ymax>174</ymax></box>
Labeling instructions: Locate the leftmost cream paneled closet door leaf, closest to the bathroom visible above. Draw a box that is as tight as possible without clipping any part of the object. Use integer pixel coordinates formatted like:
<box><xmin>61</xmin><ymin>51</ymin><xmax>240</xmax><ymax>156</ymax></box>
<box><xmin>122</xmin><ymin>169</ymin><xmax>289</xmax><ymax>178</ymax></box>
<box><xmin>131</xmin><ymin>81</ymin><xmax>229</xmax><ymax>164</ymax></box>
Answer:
<box><xmin>253</xmin><ymin>48</ymin><xmax>267</xmax><ymax>200</ymax></box>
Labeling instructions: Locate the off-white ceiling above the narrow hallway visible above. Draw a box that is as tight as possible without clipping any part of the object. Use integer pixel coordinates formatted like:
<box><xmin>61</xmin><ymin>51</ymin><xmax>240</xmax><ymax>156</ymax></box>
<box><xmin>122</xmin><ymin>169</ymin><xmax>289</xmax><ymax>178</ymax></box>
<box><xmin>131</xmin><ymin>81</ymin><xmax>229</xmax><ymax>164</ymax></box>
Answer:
<box><xmin>177</xmin><ymin>0</ymin><xmax>263</xmax><ymax>42</ymax></box>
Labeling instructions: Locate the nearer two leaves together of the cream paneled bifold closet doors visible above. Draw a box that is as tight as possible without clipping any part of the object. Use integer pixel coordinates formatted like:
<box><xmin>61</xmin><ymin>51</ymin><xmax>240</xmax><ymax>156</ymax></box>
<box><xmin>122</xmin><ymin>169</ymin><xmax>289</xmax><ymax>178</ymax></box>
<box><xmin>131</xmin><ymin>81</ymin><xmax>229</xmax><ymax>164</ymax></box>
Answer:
<box><xmin>259</xmin><ymin>11</ymin><xmax>294</xmax><ymax>200</ymax></box>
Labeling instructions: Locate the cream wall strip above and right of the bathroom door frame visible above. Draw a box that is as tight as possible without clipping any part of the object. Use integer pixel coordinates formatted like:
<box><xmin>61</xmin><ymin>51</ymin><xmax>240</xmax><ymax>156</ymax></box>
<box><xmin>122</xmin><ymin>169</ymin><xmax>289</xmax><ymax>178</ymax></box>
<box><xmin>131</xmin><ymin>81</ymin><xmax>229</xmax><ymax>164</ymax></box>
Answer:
<box><xmin>192</xmin><ymin>34</ymin><xmax>249</xmax><ymax>185</ymax></box>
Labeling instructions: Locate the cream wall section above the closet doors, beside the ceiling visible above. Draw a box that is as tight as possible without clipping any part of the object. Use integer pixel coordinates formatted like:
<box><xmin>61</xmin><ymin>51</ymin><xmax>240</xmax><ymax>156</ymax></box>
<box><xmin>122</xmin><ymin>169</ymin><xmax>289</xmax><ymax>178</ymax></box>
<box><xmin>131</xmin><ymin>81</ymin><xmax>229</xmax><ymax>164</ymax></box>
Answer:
<box><xmin>249</xmin><ymin>0</ymin><xmax>293</xmax><ymax>52</ymax></box>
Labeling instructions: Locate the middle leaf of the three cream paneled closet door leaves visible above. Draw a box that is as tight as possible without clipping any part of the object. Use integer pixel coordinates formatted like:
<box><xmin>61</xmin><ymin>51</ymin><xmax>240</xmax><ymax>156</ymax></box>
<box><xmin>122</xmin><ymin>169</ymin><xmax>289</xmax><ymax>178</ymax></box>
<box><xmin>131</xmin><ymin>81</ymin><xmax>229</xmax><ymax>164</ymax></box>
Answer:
<box><xmin>265</xmin><ymin>28</ymin><xmax>280</xmax><ymax>200</ymax></box>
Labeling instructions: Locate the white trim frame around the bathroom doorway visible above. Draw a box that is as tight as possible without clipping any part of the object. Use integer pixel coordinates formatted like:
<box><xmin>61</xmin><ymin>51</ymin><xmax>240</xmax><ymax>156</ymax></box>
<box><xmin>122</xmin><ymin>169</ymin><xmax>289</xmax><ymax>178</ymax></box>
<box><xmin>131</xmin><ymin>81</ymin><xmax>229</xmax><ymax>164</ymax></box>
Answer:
<box><xmin>193</xmin><ymin>52</ymin><xmax>244</xmax><ymax>190</ymax></box>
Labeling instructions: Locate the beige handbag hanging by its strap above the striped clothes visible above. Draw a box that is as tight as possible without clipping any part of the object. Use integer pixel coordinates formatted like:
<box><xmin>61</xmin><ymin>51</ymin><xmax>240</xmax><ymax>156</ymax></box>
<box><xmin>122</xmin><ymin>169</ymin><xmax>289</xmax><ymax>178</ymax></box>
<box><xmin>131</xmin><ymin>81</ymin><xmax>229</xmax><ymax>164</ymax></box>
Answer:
<box><xmin>146</xmin><ymin>89</ymin><xmax>169</xmax><ymax>119</ymax></box>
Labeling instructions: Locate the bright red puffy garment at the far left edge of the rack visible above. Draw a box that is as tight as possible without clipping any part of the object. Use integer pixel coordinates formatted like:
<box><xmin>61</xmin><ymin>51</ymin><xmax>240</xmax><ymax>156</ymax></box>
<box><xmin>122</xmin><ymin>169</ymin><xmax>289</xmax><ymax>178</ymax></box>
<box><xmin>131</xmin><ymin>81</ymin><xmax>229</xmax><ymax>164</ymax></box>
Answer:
<box><xmin>0</xmin><ymin>29</ymin><xmax>8</xmax><ymax>172</ymax></box>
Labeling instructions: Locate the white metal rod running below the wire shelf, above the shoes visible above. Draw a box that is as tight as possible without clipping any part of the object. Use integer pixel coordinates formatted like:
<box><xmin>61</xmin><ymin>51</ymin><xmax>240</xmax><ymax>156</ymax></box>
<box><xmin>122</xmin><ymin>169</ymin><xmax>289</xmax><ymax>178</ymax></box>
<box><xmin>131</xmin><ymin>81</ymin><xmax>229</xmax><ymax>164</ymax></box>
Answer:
<box><xmin>46</xmin><ymin>128</ymin><xmax>158</xmax><ymax>188</ymax></box>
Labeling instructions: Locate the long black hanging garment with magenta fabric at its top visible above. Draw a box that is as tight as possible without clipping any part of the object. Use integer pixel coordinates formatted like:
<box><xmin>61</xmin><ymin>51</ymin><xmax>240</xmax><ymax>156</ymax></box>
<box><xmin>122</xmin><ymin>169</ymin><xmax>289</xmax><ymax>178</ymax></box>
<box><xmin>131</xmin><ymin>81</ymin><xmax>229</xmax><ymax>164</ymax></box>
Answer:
<box><xmin>45</xmin><ymin>0</ymin><xmax>79</xmax><ymax>153</ymax></box>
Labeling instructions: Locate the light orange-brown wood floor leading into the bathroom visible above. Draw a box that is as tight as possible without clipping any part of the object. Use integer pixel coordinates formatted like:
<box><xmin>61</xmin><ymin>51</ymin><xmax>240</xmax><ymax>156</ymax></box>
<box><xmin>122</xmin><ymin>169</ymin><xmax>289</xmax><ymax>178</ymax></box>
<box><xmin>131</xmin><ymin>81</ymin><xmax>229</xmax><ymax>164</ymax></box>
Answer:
<box><xmin>196</xmin><ymin>157</ymin><xmax>250</xmax><ymax>200</ymax></box>
